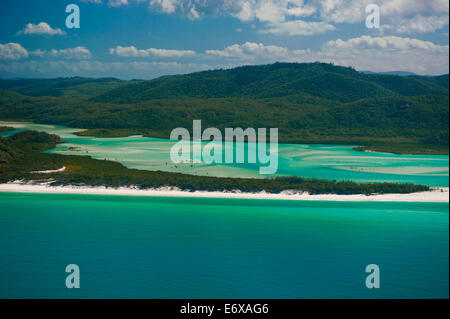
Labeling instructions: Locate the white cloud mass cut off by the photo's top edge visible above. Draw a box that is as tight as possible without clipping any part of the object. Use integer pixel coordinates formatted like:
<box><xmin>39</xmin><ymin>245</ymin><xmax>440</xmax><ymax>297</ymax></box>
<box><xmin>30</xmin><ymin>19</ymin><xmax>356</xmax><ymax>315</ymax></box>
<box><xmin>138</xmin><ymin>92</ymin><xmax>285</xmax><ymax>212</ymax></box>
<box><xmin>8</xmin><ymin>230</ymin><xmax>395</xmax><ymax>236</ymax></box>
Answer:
<box><xmin>150</xmin><ymin>0</ymin><xmax>449</xmax><ymax>23</ymax></box>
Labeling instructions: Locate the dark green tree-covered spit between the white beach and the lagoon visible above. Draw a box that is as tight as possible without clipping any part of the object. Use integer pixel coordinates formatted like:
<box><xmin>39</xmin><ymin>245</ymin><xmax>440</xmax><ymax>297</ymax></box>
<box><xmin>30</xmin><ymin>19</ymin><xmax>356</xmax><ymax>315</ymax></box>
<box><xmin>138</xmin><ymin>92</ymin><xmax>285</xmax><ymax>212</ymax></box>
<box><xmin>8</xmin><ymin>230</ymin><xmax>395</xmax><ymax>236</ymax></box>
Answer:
<box><xmin>0</xmin><ymin>131</ymin><xmax>429</xmax><ymax>195</ymax></box>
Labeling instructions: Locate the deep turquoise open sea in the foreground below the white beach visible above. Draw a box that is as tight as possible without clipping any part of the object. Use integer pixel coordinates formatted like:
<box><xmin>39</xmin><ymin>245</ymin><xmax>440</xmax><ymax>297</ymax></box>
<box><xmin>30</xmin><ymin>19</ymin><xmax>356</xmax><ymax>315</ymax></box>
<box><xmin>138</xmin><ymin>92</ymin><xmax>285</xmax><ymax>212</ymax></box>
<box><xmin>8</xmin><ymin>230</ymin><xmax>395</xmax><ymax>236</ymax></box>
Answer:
<box><xmin>0</xmin><ymin>193</ymin><xmax>449</xmax><ymax>298</ymax></box>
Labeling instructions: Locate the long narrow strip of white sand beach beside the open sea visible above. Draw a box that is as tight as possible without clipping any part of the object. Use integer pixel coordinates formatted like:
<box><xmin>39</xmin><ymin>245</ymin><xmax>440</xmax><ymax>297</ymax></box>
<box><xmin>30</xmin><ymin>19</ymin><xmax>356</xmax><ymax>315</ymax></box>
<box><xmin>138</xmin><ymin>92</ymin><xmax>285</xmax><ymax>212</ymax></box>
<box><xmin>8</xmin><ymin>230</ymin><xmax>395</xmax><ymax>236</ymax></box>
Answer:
<box><xmin>0</xmin><ymin>181</ymin><xmax>449</xmax><ymax>203</ymax></box>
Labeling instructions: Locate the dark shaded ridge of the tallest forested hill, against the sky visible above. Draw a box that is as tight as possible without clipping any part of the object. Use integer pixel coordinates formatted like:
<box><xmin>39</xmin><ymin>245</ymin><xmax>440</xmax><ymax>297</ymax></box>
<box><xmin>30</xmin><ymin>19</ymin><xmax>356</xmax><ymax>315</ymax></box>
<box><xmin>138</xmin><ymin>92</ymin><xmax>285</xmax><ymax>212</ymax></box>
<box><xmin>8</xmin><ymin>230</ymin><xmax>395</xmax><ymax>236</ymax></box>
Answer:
<box><xmin>93</xmin><ymin>63</ymin><xmax>449</xmax><ymax>103</ymax></box>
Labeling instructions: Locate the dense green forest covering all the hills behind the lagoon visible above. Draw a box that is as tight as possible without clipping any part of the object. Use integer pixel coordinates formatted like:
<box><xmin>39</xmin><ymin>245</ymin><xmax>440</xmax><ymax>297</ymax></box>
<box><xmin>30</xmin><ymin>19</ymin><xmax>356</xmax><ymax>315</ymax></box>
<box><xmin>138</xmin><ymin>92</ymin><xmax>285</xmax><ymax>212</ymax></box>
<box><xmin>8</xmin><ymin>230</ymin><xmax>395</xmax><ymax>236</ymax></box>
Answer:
<box><xmin>0</xmin><ymin>63</ymin><xmax>449</xmax><ymax>154</ymax></box>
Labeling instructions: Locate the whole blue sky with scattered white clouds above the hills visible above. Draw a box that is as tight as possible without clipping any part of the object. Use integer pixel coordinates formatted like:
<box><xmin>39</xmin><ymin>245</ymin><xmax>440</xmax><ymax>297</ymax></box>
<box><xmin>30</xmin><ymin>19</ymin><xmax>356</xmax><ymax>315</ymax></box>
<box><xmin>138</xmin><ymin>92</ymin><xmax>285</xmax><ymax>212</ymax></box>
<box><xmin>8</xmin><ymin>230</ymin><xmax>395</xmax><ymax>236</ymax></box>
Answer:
<box><xmin>0</xmin><ymin>0</ymin><xmax>449</xmax><ymax>79</ymax></box>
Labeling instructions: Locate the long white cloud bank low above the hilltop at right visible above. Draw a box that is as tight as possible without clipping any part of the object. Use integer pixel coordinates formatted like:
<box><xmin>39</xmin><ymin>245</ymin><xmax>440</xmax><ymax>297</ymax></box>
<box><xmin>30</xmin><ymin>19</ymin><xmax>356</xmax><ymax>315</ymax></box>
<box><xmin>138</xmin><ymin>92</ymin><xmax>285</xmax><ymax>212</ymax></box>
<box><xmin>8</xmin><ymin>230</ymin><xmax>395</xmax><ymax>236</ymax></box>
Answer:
<box><xmin>206</xmin><ymin>36</ymin><xmax>449</xmax><ymax>74</ymax></box>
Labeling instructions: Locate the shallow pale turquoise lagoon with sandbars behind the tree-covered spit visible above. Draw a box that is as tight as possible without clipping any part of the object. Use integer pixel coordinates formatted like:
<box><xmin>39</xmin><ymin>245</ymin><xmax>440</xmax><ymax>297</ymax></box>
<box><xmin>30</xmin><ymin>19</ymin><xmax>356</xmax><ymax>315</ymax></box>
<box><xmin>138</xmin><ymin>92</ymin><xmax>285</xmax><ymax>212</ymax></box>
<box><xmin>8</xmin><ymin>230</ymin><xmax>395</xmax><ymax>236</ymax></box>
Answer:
<box><xmin>0</xmin><ymin>121</ymin><xmax>449</xmax><ymax>186</ymax></box>
